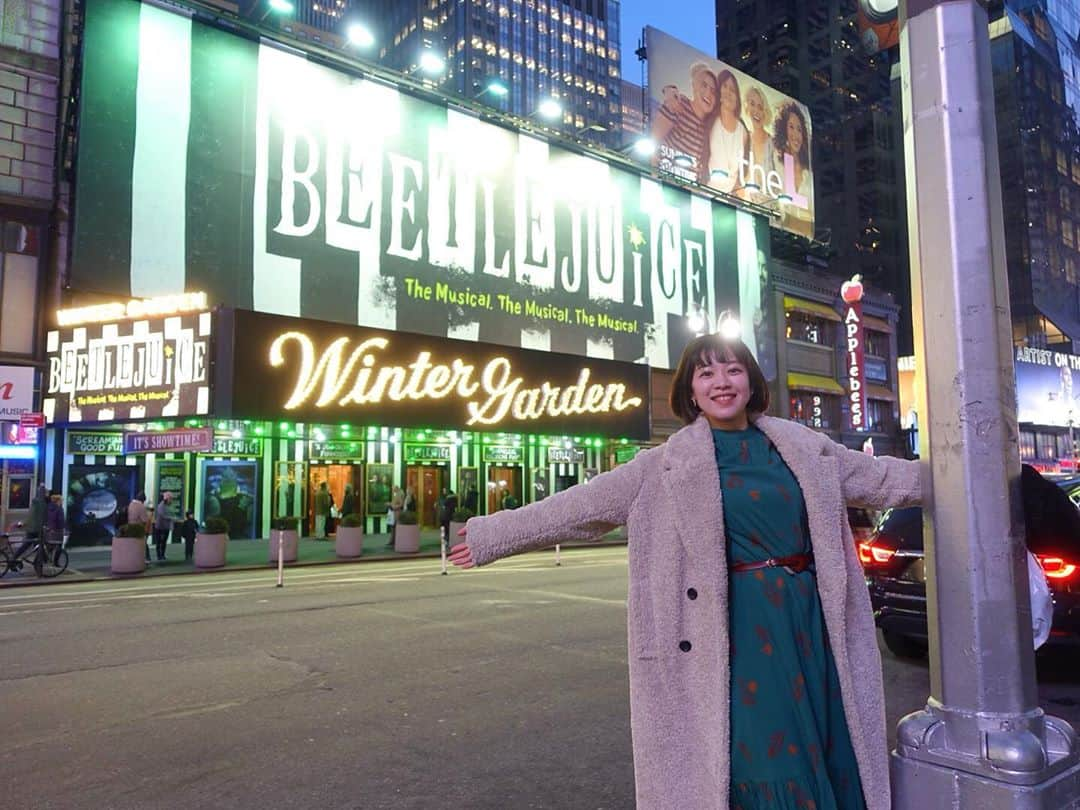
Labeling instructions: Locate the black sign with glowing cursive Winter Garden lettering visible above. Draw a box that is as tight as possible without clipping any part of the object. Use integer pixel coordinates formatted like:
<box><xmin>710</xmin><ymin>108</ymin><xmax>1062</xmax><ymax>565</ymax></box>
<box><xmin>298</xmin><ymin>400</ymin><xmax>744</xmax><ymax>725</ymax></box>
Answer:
<box><xmin>217</xmin><ymin>310</ymin><xmax>649</xmax><ymax>440</ymax></box>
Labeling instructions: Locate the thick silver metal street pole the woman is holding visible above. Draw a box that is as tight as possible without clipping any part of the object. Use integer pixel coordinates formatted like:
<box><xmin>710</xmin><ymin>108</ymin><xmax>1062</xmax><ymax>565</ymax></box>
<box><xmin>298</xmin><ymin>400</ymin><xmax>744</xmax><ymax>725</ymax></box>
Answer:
<box><xmin>891</xmin><ymin>0</ymin><xmax>1080</xmax><ymax>810</ymax></box>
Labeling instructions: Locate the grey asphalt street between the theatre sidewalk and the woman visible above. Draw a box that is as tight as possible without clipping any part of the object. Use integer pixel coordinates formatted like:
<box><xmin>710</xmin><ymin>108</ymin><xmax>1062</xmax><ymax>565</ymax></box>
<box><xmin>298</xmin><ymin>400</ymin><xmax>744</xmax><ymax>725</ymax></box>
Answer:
<box><xmin>0</xmin><ymin>548</ymin><xmax>1080</xmax><ymax>810</ymax></box>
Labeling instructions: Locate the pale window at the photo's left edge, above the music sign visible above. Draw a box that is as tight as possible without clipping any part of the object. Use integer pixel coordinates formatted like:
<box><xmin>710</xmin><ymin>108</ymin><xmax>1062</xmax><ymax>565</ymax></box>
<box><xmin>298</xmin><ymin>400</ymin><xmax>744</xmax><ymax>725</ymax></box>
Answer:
<box><xmin>0</xmin><ymin>221</ymin><xmax>40</xmax><ymax>354</ymax></box>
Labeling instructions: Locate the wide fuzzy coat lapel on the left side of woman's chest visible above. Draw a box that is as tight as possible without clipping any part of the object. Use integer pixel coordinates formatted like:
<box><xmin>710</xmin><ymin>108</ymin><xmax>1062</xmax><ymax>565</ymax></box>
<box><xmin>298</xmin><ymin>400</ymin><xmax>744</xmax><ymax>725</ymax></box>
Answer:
<box><xmin>662</xmin><ymin>417</ymin><xmax>726</xmax><ymax>567</ymax></box>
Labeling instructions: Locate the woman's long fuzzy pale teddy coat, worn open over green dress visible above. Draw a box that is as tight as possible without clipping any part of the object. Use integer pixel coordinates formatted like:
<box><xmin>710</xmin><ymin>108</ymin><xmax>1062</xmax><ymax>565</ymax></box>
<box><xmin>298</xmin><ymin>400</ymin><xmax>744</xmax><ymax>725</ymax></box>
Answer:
<box><xmin>467</xmin><ymin>416</ymin><xmax>921</xmax><ymax>810</ymax></box>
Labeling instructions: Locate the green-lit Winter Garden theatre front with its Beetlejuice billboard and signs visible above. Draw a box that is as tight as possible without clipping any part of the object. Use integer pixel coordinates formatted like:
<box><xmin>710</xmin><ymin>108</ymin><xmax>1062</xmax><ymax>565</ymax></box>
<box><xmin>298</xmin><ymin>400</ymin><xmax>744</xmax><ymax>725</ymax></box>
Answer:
<box><xmin>40</xmin><ymin>0</ymin><xmax>775</xmax><ymax>543</ymax></box>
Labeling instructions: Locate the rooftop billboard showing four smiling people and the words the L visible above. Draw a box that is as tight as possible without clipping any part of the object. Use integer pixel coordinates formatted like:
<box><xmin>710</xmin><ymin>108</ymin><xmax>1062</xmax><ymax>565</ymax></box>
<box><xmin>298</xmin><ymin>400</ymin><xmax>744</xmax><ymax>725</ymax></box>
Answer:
<box><xmin>645</xmin><ymin>28</ymin><xmax>814</xmax><ymax>239</ymax></box>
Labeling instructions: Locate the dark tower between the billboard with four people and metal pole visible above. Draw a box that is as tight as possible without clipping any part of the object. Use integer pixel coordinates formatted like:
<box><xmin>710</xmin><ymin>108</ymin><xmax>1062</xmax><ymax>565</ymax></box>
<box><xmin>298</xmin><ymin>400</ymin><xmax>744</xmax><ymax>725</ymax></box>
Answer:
<box><xmin>716</xmin><ymin>0</ymin><xmax>912</xmax><ymax>348</ymax></box>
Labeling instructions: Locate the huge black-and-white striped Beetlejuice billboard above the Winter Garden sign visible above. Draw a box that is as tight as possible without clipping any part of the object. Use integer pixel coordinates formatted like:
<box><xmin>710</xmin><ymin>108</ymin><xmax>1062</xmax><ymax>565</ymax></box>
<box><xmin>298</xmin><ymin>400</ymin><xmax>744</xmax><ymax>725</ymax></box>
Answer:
<box><xmin>71</xmin><ymin>0</ymin><xmax>770</xmax><ymax>368</ymax></box>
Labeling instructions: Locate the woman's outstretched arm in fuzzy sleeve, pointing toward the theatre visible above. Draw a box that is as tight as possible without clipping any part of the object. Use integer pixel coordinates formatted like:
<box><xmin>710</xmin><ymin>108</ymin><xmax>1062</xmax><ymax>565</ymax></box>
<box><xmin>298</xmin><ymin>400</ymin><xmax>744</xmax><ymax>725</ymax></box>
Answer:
<box><xmin>449</xmin><ymin>448</ymin><xmax>659</xmax><ymax>568</ymax></box>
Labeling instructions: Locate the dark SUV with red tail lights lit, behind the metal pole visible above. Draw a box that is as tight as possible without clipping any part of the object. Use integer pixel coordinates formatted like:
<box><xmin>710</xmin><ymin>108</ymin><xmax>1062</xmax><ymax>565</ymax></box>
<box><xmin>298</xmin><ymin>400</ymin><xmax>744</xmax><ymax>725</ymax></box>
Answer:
<box><xmin>858</xmin><ymin>475</ymin><xmax>1080</xmax><ymax>658</ymax></box>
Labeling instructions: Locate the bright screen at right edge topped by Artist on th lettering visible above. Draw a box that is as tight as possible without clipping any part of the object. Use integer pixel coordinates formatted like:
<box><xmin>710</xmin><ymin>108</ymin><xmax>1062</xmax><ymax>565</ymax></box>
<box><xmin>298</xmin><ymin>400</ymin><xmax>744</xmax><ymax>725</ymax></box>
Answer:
<box><xmin>1014</xmin><ymin>347</ymin><xmax>1080</xmax><ymax>428</ymax></box>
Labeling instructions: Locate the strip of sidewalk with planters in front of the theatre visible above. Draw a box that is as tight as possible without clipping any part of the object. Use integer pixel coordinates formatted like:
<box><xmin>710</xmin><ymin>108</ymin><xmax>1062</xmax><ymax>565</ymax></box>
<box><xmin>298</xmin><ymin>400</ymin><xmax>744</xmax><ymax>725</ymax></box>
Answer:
<box><xmin>0</xmin><ymin>529</ymin><xmax>626</xmax><ymax>589</ymax></box>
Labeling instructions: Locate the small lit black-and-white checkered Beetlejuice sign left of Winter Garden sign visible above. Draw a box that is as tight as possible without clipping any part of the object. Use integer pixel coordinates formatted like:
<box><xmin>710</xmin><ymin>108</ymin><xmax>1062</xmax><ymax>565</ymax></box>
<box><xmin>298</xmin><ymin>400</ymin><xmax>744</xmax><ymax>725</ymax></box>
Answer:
<box><xmin>42</xmin><ymin>312</ymin><xmax>214</xmax><ymax>424</ymax></box>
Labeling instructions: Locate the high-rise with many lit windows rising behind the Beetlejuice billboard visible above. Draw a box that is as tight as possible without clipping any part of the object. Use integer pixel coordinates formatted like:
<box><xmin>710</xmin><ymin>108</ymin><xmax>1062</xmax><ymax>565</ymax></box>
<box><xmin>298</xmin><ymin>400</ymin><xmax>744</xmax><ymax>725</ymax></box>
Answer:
<box><xmin>355</xmin><ymin>0</ymin><xmax>621</xmax><ymax>147</ymax></box>
